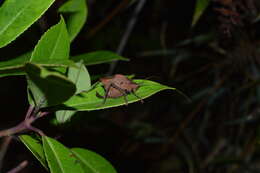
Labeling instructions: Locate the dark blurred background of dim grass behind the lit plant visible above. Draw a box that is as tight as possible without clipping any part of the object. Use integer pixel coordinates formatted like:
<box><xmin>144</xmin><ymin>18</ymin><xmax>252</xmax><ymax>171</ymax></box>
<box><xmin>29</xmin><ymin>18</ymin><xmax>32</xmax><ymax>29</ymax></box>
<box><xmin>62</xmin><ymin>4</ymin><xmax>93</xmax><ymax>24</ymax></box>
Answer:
<box><xmin>0</xmin><ymin>0</ymin><xmax>260</xmax><ymax>173</ymax></box>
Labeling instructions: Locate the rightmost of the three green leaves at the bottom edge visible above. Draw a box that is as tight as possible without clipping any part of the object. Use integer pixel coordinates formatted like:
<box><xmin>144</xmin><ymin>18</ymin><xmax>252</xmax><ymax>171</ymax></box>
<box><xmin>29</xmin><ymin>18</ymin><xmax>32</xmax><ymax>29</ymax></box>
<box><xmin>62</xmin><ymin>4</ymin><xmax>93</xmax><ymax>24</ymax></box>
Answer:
<box><xmin>71</xmin><ymin>148</ymin><xmax>116</xmax><ymax>173</ymax></box>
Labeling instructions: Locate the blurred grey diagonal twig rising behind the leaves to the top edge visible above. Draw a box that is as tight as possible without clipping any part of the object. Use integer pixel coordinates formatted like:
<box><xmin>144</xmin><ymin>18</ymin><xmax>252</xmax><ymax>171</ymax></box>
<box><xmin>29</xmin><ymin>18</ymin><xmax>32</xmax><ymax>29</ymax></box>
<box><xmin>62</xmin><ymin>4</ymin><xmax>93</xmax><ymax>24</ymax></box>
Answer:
<box><xmin>107</xmin><ymin>0</ymin><xmax>146</xmax><ymax>75</ymax></box>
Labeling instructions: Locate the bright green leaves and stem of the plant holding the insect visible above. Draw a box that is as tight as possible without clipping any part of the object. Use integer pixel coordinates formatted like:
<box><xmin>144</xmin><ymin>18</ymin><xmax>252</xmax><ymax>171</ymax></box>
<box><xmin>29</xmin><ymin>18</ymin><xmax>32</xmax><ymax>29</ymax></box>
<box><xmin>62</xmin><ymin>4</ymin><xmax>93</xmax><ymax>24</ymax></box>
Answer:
<box><xmin>0</xmin><ymin>0</ymin><xmax>179</xmax><ymax>173</ymax></box>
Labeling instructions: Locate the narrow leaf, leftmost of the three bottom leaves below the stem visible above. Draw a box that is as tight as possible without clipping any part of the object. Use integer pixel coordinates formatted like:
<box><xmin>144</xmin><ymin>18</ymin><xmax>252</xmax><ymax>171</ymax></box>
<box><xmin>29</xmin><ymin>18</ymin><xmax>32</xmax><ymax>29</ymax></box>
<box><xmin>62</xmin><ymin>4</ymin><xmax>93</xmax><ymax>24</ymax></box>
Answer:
<box><xmin>19</xmin><ymin>135</ymin><xmax>48</xmax><ymax>170</ymax></box>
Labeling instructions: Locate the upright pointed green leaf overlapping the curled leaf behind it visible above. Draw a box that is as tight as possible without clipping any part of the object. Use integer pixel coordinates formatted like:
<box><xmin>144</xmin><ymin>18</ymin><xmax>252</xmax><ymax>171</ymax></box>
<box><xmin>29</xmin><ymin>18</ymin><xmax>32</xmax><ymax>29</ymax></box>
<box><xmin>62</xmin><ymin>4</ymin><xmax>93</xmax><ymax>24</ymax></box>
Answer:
<box><xmin>30</xmin><ymin>18</ymin><xmax>70</xmax><ymax>64</ymax></box>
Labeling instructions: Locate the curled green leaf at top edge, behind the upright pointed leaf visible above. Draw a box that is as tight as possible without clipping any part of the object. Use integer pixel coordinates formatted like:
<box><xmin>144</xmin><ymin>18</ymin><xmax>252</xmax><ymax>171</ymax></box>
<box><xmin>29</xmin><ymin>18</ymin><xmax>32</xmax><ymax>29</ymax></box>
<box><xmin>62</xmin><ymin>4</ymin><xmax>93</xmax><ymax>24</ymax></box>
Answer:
<box><xmin>59</xmin><ymin>0</ymin><xmax>88</xmax><ymax>41</ymax></box>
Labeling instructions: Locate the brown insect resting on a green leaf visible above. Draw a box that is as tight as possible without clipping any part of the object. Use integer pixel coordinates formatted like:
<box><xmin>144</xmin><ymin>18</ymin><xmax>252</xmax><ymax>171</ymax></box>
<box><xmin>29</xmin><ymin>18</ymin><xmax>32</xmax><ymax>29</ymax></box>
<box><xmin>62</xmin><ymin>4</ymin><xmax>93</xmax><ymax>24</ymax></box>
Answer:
<box><xmin>96</xmin><ymin>74</ymin><xmax>143</xmax><ymax>105</ymax></box>
